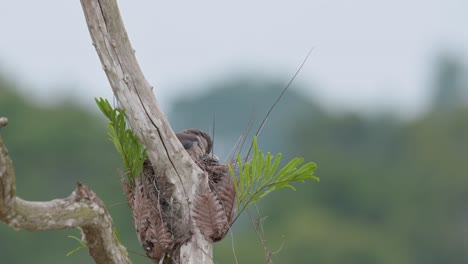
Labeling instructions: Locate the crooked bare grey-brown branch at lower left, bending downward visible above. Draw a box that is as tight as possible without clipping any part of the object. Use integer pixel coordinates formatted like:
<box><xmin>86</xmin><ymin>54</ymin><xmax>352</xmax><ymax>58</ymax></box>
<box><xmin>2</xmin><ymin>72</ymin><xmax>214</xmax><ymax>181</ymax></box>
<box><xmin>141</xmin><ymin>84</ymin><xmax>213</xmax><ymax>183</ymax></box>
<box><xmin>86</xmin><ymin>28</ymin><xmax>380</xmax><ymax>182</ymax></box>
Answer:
<box><xmin>0</xmin><ymin>117</ymin><xmax>131</xmax><ymax>264</ymax></box>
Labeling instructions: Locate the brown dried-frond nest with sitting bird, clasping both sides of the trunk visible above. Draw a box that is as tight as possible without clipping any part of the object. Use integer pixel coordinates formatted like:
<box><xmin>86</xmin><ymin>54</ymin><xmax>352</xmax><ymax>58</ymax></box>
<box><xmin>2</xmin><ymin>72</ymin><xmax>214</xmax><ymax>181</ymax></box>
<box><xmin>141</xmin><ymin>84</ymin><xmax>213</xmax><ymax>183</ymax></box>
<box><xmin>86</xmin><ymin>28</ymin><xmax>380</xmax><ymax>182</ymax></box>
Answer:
<box><xmin>122</xmin><ymin>129</ymin><xmax>236</xmax><ymax>263</ymax></box>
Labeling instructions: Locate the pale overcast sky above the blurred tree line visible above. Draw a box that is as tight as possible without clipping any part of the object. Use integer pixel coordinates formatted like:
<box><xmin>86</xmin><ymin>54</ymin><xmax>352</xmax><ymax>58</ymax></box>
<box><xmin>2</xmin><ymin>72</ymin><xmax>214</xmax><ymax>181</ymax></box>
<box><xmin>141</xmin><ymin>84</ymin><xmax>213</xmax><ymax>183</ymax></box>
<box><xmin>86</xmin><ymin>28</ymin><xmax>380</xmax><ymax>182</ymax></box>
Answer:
<box><xmin>0</xmin><ymin>0</ymin><xmax>468</xmax><ymax>115</ymax></box>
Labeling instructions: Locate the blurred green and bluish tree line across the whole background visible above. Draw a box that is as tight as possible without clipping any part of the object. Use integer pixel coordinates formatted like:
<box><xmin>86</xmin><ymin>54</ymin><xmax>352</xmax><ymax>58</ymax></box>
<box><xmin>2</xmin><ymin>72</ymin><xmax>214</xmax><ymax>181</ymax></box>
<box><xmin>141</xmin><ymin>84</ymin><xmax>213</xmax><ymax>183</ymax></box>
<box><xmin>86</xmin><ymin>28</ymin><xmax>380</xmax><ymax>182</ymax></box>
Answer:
<box><xmin>0</xmin><ymin>52</ymin><xmax>468</xmax><ymax>264</ymax></box>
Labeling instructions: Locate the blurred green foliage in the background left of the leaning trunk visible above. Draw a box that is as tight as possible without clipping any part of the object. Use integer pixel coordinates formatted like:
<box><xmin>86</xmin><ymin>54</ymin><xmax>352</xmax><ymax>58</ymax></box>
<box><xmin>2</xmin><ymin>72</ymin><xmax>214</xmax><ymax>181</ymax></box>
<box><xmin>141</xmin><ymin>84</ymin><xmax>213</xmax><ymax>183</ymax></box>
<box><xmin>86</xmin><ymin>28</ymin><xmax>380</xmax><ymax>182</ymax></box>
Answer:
<box><xmin>0</xmin><ymin>80</ymin><xmax>151</xmax><ymax>264</ymax></box>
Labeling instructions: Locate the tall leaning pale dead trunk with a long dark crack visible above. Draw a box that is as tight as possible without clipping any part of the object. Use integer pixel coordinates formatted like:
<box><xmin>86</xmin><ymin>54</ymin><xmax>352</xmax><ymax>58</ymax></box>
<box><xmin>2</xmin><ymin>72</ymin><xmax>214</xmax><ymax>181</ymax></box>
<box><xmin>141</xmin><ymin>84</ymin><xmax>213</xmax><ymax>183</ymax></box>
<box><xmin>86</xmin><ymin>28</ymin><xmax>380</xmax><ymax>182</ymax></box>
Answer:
<box><xmin>81</xmin><ymin>0</ymin><xmax>213</xmax><ymax>263</ymax></box>
